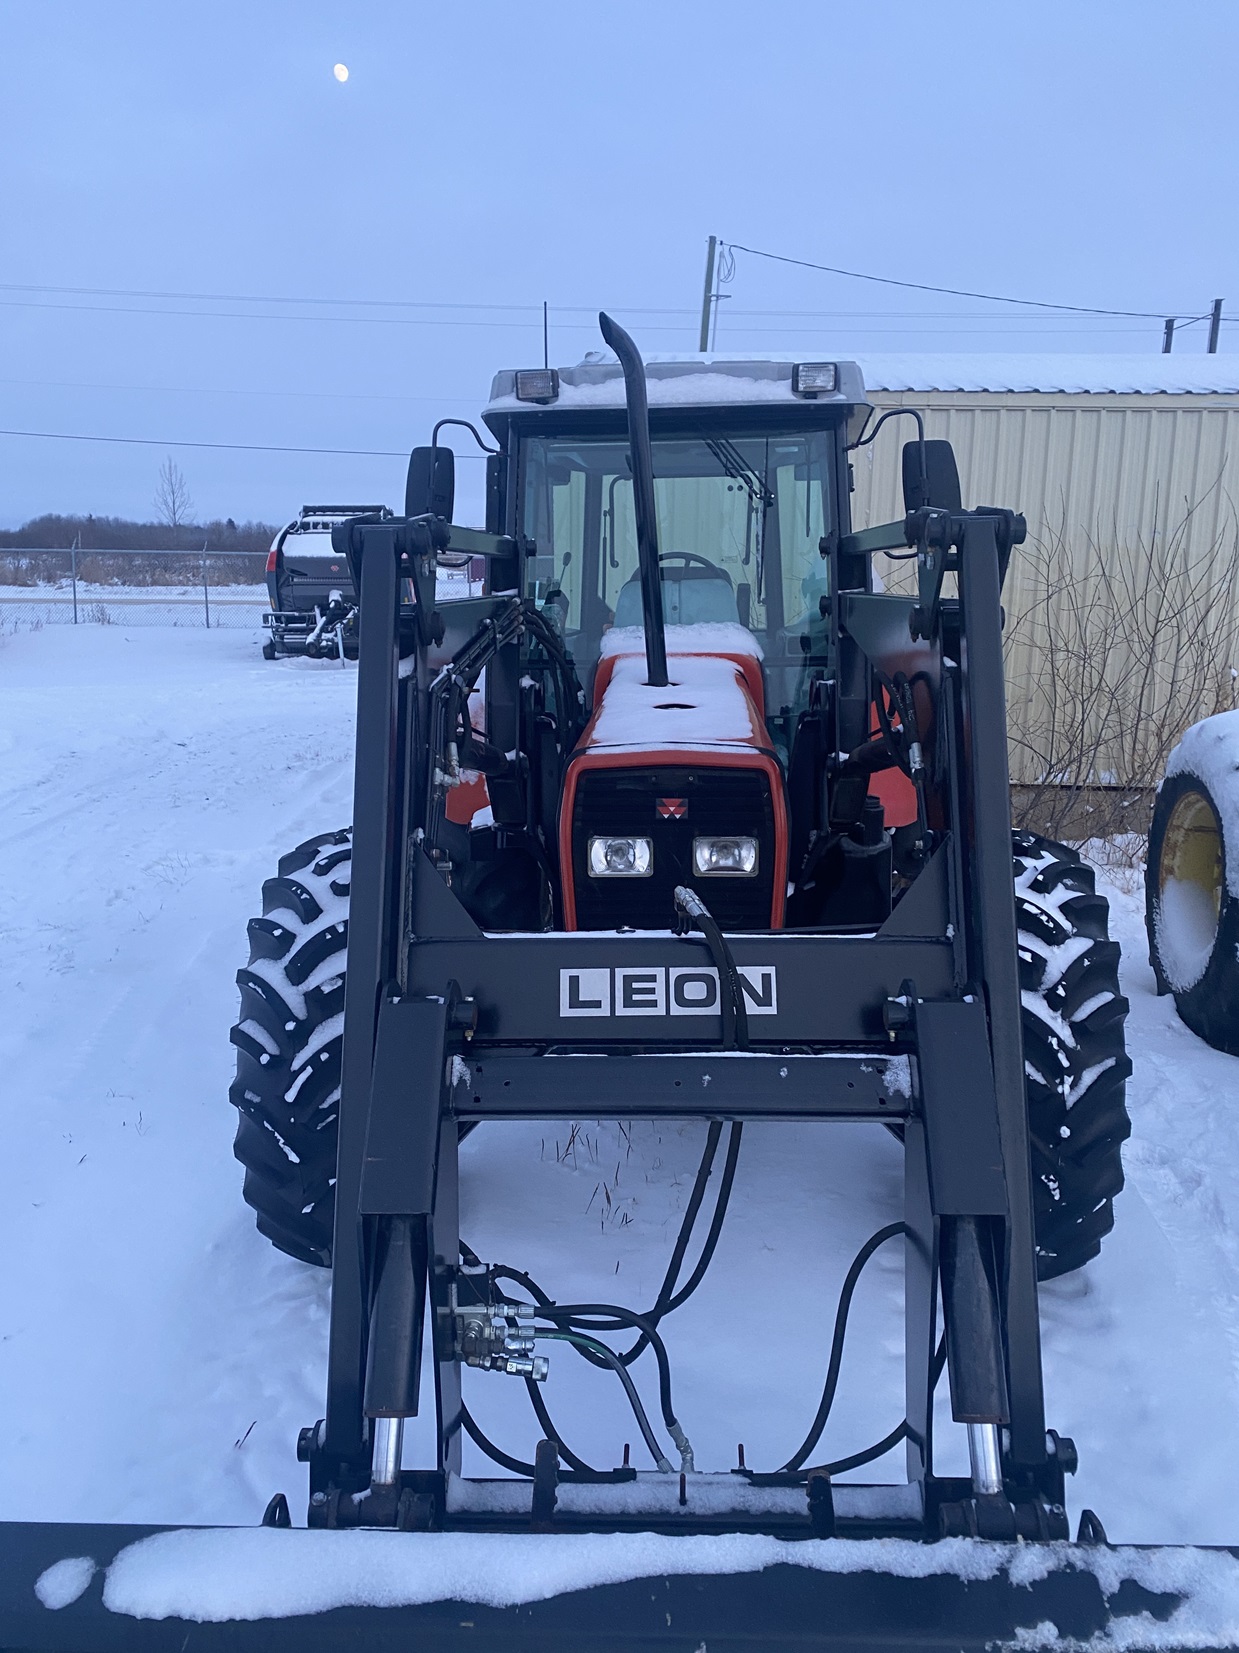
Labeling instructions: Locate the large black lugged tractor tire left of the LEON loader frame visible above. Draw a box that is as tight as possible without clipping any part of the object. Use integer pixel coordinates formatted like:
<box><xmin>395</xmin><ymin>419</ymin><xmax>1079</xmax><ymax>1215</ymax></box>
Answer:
<box><xmin>228</xmin><ymin>828</ymin><xmax>352</xmax><ymax>1266</ymax></box>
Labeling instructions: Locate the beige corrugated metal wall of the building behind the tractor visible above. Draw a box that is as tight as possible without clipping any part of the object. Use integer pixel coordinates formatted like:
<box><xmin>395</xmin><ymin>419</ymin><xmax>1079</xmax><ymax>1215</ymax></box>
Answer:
<box><xmin>852</xmin><ymin>390</ymin><xmax>1239</xmax><ymax>784</ymax></box>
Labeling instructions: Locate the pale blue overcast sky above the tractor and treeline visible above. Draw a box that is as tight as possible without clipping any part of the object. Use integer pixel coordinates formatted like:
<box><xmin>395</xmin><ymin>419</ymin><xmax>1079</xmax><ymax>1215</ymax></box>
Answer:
<box><xmin>0</xmin><ymin>0</ymin><xmax>1239</xmax><ymax>526</ymax></box>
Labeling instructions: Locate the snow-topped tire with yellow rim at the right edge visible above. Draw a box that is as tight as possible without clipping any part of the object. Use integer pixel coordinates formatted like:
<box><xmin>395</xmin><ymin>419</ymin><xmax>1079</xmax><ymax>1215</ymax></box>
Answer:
<box><xmin>1145</xmin><ymin>757</ymin><xmax>1239</xmax><ymax>1056</ymax></box>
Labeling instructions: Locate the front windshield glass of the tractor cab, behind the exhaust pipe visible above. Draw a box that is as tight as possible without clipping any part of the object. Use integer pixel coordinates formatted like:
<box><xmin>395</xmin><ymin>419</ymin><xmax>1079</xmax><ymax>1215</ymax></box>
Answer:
<box><xmin>520</xmin><ymin>430</ymin><xmax>834</xmax><ymax>737</ymax></box>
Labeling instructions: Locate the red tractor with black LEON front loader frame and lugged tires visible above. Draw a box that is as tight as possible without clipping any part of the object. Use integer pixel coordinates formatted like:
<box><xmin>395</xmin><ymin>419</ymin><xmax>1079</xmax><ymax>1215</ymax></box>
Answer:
<box><xmin>231</xmin><ymin>316</ymin><xmax>1130</xmax><ymax>1560</ymax></box>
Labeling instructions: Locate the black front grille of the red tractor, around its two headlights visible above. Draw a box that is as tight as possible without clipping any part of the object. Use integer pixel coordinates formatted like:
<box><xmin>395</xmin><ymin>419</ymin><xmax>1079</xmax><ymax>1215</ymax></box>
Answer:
<box><xmin>572</xmin><ymin>765</ymin><xmax>775</xmax><ymax>931</ymax></box>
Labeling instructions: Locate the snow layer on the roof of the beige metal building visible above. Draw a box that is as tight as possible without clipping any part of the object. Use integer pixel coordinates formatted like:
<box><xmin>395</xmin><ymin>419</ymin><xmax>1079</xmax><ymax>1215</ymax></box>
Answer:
<box><xmin>856</xmin><ymin>352</ymin><xmax>1239</xmax><ymax>397</ymax></box>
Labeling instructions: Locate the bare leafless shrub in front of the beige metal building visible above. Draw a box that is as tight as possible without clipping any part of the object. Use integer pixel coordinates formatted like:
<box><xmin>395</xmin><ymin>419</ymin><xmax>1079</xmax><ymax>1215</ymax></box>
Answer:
<box><xmin>1006</xmin><ymin>509</ymin><xmax>1239</xmax><ymax>840</ymax></box>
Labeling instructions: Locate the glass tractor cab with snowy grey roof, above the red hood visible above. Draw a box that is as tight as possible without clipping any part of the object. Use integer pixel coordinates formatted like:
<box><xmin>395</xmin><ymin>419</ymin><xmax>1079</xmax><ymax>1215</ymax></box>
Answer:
<box><xmin>484</xmin><ymin>357</ymin><xmax>871</xmax><ymax>760</ymax></box>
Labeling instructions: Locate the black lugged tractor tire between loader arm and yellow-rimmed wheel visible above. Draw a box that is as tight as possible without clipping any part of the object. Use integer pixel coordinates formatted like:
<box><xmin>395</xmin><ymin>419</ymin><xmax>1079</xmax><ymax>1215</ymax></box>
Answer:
<box><xmin>1013</xmin><ymin>831</ymin><xmax>1132</xmax><ymax>1279</ymax></box>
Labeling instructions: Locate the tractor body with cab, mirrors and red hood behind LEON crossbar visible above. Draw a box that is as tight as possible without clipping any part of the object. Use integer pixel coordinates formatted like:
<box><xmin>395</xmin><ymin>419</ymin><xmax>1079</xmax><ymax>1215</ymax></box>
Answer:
<box><xmin>388</xmin><ymin>317</ymin><xmax>958</xmax><ymax>931</ymax></box>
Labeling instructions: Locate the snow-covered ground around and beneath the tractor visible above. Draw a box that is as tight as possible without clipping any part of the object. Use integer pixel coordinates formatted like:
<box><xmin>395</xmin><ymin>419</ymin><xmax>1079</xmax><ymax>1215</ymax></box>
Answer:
<box><xmin>0</xmin><ymin>625</ymin><xmax>1239</xmax><ymax>1542</ymax></box>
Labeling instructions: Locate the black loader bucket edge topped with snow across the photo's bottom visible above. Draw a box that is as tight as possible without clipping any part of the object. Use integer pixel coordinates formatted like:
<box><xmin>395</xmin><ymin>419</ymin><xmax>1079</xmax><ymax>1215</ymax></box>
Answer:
<box><xmin>0</xmin><ymin>1522</ymin><xmax>1239</xmax><ymax>1653</ymax></box>
